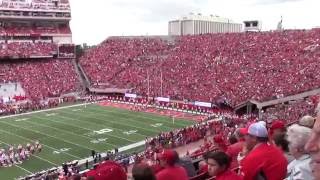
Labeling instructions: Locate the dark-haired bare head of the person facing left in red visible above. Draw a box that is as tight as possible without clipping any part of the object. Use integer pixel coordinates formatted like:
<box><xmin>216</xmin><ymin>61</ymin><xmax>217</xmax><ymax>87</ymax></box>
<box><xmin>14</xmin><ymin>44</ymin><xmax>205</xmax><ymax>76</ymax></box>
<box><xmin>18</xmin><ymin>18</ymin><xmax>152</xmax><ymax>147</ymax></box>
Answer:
<box><xmin>206</xmin><ymin>151</ymin><xmax>231</xmax><ymax>176</ymax></box>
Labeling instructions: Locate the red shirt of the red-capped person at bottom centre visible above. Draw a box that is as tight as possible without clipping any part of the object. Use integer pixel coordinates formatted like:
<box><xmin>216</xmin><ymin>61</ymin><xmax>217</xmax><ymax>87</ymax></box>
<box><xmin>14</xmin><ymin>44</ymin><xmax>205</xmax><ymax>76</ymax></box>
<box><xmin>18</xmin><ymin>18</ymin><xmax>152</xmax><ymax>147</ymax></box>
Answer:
<box><xmin>156</xmin><ymin>166</ymin><xmax>189</xmax><ymax>180</ymax></box>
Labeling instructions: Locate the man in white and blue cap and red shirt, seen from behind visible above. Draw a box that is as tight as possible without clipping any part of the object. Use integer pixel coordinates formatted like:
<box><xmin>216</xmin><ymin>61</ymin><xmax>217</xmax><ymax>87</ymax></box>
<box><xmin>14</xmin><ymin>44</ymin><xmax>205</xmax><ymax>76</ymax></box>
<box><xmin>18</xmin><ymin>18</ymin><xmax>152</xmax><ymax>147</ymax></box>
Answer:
<box><xmin>240</xmin><ymin>123</ymin><xmax>288</xmax><ymax>180</ymax></box>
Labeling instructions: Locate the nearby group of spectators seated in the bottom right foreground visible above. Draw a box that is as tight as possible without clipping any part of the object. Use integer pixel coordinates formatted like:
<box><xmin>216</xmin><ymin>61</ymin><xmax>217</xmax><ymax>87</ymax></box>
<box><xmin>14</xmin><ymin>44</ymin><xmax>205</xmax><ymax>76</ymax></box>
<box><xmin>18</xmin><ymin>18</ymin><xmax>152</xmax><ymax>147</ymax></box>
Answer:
<box><xmin>127</xmin><ymin>105</ymin><xmax>320</xmax><ymax>180</ymax></box>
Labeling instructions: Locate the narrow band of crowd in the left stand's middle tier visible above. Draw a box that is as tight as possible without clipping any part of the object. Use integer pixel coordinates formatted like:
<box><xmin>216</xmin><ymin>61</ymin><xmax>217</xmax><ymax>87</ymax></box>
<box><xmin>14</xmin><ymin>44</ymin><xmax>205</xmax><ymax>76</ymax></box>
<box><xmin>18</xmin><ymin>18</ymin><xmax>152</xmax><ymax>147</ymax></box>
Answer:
<box><xmin>0</xmin><ymin>42</ymin><xmax>57</xmax><ymax>59</ymax></box>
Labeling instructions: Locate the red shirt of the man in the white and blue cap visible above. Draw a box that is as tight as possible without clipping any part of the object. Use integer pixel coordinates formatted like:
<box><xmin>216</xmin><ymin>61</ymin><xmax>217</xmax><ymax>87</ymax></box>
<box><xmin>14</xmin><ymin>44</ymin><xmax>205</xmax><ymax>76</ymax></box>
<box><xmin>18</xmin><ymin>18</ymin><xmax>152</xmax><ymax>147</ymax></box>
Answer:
<box><xmin>241</xmin><ymin>143</ymin><xmax>288</xmax><ymax>180</ymax></box>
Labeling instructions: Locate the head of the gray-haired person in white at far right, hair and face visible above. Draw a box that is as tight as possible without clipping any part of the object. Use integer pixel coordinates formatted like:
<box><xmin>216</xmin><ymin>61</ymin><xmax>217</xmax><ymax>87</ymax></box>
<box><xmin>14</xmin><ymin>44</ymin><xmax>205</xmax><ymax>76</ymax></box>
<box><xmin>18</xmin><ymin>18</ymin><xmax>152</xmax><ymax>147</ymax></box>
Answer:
<box><xmin>287</xmin><ymin>124</ymin><xmax>311</xmax><ymax>159</ymax></box>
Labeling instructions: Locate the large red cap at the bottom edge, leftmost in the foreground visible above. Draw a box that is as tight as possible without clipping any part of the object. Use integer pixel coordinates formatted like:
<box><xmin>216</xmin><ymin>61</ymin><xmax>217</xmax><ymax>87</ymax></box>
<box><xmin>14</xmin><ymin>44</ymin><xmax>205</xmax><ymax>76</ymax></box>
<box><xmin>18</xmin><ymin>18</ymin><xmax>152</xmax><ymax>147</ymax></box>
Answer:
<box><xmin>87</xmin><ymin>161</ymin><xmax>127</xmax><ymax>180</ymax></box>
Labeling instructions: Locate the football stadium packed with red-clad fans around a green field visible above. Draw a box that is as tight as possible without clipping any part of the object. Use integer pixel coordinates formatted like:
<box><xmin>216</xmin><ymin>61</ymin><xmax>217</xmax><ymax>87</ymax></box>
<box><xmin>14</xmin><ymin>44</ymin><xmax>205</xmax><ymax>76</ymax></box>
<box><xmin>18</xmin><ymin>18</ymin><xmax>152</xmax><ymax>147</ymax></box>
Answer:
<box><xmin>0</xmin><ymin>0</ymin><xmax>320</xmax><ymax>180</ymax></box>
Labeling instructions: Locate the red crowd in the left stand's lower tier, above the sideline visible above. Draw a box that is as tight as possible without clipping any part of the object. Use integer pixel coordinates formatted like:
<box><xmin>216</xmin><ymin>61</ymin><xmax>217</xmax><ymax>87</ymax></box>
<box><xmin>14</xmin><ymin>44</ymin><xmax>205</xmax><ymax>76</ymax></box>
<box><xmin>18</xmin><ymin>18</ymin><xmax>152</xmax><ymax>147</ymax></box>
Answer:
<box><xmin>0</xmin><ymin>59</ymin><xmax>79</xmax><ymax>101</ymax></box>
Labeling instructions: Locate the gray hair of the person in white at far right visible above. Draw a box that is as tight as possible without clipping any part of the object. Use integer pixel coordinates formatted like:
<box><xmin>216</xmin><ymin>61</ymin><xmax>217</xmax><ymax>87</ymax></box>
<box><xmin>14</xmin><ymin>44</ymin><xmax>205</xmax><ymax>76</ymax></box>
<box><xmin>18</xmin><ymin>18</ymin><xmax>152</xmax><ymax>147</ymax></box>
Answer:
<box><xmin>287</xmin><ymin>124</ymin><xmax>311</xmax><ymax>149</ymax></box>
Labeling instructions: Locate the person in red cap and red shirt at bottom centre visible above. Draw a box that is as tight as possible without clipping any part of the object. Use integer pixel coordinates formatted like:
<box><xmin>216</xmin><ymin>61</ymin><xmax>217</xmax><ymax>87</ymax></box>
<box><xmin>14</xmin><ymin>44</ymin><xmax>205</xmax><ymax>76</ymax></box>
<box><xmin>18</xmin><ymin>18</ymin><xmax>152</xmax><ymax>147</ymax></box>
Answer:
<box><xmin>156</xmin><ymin>149</ymin><xmax>189</xmax><ymax>180</ymax></box>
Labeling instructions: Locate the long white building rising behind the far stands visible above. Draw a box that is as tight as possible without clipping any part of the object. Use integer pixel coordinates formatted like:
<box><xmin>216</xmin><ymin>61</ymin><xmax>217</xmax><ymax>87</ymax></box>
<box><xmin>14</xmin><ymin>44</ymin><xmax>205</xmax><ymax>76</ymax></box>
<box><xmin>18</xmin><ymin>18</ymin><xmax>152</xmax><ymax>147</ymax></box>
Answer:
<box><xmin>168</xmin><ymin>13</ymin><xmax>242</xmax><ymax>36</ymax></box>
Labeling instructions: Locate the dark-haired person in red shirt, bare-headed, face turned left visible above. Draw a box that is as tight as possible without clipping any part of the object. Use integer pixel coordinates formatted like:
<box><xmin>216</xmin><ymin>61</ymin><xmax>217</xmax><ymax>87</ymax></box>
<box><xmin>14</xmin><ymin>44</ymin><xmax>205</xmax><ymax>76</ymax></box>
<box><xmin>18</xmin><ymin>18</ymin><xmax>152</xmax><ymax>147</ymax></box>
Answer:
<box><xmin>206</xmin><ymin>151</ymin><xmax>242</xmax><ymax>180</ymax></box>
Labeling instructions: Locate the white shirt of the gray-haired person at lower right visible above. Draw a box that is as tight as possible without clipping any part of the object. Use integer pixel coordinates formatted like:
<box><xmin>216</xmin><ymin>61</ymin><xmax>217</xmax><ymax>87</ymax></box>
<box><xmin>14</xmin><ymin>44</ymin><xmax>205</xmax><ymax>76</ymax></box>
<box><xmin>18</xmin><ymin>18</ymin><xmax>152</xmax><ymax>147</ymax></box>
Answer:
<box><xmin>286</xmin><ymin>154</ymin><xmax>314</xmax><ymax>180</ymax></box>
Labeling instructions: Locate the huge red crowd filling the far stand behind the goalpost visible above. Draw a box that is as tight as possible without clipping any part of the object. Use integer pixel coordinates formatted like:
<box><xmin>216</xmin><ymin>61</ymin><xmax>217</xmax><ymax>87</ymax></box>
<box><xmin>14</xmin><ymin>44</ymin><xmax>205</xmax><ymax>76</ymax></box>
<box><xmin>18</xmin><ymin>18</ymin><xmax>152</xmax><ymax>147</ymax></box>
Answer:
<box><xmin>80</xmin><ymin>29</ymin><xmax>320</xmax><ymax>105</ymax></box>
